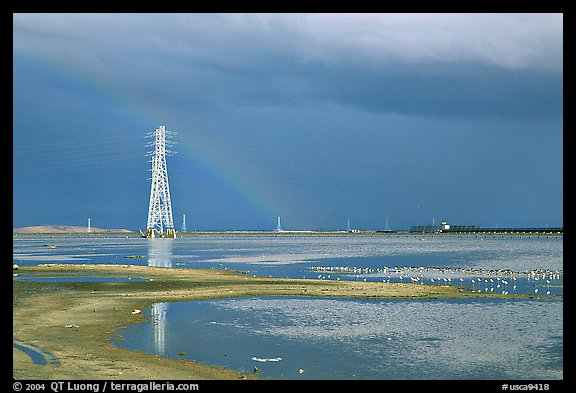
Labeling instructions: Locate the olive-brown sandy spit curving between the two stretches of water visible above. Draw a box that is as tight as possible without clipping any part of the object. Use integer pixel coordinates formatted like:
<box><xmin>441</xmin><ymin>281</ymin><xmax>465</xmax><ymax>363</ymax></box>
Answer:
<box><xmin>13</xmin><ymin>264</ymin><xmax>510</xmax><ymax>380</ymax></box>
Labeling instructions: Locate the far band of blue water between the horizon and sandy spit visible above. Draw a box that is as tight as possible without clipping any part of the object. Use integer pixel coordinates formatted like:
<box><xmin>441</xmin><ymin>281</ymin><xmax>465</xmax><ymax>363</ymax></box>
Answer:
<box><xmin>13</xmin><ymin>235</ymin><xmax>563</xmax><ymax>297</ymax></box>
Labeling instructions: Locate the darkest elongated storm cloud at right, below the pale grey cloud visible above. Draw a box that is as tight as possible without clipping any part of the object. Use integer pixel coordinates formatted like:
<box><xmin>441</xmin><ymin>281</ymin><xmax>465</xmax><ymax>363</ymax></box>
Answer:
<box><xmin>306</xmin><ymin>62</ymin><xmax>563</xmax><ymax>118</ymax></box>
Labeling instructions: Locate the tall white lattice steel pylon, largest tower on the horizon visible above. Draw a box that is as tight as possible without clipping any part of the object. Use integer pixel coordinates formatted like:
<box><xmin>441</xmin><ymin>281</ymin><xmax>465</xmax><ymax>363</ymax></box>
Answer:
<box><xmin>146</xmin><ymin>126</ymin><xmax>176</xmax><ymax>238</ymax></box>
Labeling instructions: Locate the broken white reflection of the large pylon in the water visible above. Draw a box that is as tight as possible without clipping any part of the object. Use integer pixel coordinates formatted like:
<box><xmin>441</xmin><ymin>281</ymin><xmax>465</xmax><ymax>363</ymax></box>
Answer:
<box><xmin>148</xmin><ymin>238</ymin><xmax>172</xmax><ymax>355</ymax></box>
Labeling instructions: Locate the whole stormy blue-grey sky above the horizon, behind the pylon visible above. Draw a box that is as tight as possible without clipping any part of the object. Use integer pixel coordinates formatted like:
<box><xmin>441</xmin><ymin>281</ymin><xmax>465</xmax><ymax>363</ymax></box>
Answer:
<box><xmin>13</xmin><ymin>14</ymin><xmax>563</xmax><ymax>230</ymax></box>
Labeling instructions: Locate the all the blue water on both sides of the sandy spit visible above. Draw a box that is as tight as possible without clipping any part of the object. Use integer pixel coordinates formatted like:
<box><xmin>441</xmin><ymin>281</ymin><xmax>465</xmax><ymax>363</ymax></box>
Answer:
<box><xmin>13</xmin><ymin>235</ymin><xmax>563</xmax><ymax>379</ymax></box>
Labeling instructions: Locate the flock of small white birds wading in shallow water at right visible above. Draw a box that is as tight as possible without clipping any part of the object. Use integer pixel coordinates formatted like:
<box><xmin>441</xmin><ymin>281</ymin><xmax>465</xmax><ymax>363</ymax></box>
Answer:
<box><xmin>311</xmin><ymin>266</ymin><xmax>563</xmax><ymax>295</ymax></box>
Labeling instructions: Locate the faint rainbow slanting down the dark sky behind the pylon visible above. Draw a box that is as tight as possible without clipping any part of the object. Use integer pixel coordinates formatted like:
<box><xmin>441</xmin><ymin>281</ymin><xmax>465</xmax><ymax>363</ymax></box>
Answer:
<box><xmin>13</xmin><ymin>45</ymin><xmax>303</xmax><ymax>229</ymax></box>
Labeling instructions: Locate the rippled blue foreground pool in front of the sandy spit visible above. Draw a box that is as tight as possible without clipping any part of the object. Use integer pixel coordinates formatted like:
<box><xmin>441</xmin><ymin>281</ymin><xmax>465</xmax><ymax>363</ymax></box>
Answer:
<box><xmin>118</xmin><ymin>297</ymin><xmax>563</xmax><ymax>380</ymax></box>
